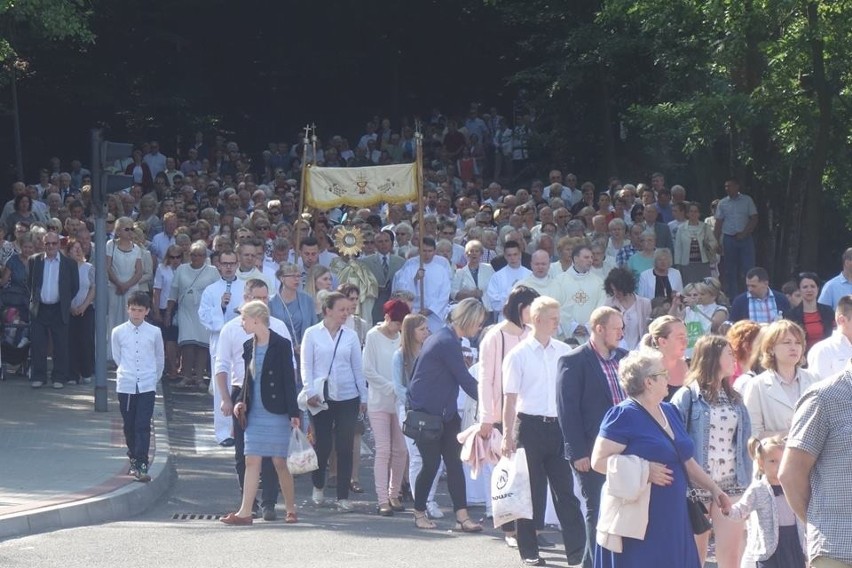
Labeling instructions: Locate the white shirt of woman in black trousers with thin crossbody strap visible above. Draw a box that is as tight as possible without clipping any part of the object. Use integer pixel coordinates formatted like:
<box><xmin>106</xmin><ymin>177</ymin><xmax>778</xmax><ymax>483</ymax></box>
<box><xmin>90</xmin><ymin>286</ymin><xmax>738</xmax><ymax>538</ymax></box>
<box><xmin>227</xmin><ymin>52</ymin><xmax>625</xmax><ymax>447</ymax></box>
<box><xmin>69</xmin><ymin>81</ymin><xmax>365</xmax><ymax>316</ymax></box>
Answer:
<box><xmin>300</xmin><ymin>322</ymin><xmax>367</xmax><ymax>403</ymax></box>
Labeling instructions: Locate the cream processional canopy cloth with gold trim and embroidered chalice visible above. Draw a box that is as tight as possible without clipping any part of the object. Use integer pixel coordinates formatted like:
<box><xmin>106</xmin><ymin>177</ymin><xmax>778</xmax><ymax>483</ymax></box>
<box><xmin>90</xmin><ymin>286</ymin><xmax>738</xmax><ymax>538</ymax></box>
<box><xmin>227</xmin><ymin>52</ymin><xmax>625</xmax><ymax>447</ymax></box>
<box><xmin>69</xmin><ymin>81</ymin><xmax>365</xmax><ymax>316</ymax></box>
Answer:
<box><xmin>305</xmin><ymin>162</ymin><xmax>418</xmax><ymax>209</ymax></box>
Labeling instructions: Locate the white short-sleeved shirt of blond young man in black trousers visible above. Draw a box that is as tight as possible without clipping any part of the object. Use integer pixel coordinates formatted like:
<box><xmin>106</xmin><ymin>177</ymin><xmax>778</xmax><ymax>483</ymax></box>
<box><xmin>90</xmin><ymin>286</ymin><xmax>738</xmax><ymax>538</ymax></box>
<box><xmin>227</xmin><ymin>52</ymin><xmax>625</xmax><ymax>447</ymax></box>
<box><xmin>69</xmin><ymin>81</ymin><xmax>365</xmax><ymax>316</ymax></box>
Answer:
<box><xmin>503</xmin><ymin>335</ymin><xmax>571</xmax><ymax>417</ymax></box>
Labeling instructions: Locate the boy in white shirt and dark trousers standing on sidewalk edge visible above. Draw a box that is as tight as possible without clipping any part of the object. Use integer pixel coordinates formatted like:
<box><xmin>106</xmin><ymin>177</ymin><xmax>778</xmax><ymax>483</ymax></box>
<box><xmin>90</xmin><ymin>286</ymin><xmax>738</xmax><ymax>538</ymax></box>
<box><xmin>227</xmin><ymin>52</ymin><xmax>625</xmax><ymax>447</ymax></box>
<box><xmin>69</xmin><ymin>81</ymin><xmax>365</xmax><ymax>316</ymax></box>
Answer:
<box><xmin>112</xmin><ymin>292</ymin><xmax>165</xmax><ymax>482</ymax></box>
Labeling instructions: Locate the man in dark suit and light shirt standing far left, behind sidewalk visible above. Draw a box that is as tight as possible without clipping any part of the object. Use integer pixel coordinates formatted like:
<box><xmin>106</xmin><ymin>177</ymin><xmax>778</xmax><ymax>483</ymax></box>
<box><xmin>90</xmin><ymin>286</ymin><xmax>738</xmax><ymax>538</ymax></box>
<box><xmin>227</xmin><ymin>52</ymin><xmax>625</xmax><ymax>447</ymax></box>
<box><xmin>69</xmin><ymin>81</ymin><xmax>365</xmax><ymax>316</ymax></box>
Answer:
<box><xmin>27</xmin><ymin>232</ymin><xmax>80</xmax><ymax>389</ymax></box>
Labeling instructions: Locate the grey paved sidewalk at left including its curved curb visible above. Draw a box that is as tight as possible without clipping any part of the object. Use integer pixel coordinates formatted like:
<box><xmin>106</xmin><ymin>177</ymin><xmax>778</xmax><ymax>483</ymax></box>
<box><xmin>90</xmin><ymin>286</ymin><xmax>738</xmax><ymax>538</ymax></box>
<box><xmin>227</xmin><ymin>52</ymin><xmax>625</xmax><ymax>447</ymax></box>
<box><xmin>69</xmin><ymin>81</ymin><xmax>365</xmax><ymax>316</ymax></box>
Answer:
<box><xmin>0</xmin><ymin>374</ymin><xmax>175</xmax><ymax>540</ymax></box>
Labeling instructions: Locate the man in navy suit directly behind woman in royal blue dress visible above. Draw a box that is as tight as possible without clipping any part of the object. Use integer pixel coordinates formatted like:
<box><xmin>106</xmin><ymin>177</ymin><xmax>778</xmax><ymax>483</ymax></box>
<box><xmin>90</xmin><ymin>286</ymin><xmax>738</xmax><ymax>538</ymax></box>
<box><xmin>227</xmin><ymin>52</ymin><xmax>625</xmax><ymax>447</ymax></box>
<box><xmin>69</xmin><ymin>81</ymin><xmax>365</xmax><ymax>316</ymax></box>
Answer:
<box><xmin>556</xmin><ymin>306</ymin><xmax>627</xmax><ymax>568</ymax></box>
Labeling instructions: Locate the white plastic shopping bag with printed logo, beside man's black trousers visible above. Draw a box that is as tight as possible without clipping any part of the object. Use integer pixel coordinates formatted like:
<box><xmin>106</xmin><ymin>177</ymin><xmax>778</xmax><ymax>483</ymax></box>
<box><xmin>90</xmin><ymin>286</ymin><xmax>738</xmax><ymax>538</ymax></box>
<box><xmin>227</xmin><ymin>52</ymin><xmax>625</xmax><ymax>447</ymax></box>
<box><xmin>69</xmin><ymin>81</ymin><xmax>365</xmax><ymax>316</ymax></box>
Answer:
<box><xmin>491</xmin><ymin>448</ymin><xmax>532</xmax><ymax>528</ymax></box>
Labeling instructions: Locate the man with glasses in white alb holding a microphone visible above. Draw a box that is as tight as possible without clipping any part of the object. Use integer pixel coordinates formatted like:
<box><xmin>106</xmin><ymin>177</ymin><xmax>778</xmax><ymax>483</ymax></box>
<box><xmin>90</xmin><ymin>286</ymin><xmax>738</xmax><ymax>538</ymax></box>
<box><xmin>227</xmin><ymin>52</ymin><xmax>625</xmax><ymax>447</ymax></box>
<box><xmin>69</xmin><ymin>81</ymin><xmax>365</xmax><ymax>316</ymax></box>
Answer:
<box><xmin>198</xmin><ymin>252</ymin><xmax>245</xmax><ymax>447</ymax></box>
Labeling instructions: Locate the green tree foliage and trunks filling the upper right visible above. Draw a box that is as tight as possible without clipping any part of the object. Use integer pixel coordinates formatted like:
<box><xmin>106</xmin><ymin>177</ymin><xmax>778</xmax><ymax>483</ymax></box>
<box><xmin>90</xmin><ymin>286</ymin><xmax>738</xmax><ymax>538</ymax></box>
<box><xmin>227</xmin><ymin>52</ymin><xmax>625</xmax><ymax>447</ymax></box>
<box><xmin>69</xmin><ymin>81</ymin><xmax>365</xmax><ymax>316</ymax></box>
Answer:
<box><xmin>490</xmin><ymin>0</ymin><xmax>852</xmax><ymax>274</ymax></box>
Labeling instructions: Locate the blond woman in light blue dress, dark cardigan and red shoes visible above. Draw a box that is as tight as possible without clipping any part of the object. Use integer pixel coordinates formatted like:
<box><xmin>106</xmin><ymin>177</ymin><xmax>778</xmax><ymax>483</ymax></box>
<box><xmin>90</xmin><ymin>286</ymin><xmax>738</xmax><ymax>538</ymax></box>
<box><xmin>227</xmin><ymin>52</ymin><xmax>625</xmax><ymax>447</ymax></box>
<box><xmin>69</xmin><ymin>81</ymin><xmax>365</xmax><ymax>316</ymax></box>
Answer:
<box><xmin>220</xmin><ymin>300</ymin><xmax>299</xmax><ymax>525</ymax></box>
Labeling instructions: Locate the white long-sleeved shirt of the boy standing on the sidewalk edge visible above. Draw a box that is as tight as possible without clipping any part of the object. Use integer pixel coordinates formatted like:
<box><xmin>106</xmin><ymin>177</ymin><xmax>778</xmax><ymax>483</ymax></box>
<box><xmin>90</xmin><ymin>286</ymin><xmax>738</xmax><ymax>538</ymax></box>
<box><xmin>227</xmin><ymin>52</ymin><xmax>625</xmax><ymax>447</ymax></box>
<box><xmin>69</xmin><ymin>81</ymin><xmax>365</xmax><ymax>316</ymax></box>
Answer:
<box><xmin>112</xmin><ymin>320</ymin><xmax>165</xmax><ymax>394</ymax></box>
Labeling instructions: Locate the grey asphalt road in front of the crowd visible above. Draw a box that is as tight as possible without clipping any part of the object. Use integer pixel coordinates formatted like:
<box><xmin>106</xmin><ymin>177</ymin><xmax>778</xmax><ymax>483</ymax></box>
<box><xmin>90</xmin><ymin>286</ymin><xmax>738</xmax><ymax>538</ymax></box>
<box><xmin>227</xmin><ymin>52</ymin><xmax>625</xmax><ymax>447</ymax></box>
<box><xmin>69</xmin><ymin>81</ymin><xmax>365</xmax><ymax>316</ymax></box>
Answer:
<box><xmin>0</xmin><ymin>387</ymin><xmax>568</xmax><ymax>568</ymax></box>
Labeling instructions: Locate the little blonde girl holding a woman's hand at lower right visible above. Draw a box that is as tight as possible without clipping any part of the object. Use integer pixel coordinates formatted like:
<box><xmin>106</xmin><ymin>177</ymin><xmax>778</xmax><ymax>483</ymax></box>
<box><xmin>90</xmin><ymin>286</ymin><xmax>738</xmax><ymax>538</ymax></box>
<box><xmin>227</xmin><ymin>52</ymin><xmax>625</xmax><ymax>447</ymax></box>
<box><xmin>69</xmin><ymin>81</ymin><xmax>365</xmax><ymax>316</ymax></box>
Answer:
<box><xmin>730</xmin><ymin>436</ymin><xmax>805</xmax><ymax>568</ymax></box>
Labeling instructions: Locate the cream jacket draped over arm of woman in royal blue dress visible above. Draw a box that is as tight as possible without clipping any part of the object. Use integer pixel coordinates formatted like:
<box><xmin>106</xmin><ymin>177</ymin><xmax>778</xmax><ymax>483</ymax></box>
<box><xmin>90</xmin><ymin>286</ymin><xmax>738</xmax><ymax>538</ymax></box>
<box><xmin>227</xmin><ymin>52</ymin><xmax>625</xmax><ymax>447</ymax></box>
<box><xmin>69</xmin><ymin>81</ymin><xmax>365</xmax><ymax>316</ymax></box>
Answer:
<box><xmin>595</xmin><ymin>455</ymin><xmax>651</xmax><ymax>552</ymax></box>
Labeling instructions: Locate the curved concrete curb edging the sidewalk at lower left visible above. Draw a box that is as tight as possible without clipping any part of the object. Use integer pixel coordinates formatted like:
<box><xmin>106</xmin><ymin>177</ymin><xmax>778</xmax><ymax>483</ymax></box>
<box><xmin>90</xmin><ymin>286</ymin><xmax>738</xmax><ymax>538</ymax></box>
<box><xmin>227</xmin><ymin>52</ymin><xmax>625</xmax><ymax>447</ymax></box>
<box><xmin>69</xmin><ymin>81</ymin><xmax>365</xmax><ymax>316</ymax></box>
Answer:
<box><xmin>0</xmin><ymin>389</ymin><xmax>177</xmax><ymax>540</ymax></box>
